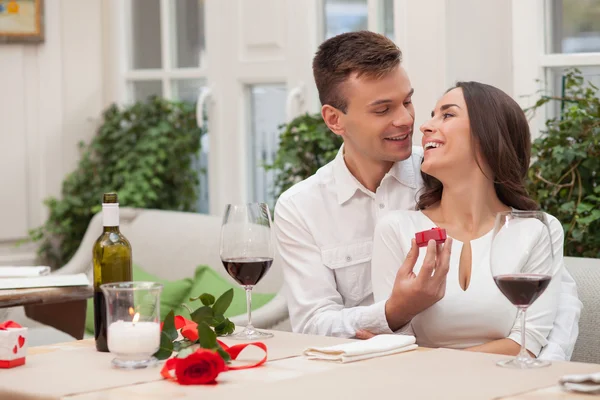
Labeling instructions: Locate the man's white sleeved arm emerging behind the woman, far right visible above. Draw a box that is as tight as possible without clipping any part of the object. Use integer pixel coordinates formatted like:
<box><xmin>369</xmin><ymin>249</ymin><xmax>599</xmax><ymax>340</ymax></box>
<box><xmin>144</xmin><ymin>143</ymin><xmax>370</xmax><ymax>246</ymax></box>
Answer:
<box><xmin>539</xmin><ymin>267</ymin><xmax>583</xmax><ymax>361</ymax></box>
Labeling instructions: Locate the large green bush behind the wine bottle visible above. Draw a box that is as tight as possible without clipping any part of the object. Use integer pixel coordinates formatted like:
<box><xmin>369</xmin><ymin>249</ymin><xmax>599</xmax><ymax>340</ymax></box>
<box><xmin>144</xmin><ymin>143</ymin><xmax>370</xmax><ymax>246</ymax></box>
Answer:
<box><xmin>30</xmin><ymin>97</ymin><xmax>203</xmax><ymax>267</ymax></box>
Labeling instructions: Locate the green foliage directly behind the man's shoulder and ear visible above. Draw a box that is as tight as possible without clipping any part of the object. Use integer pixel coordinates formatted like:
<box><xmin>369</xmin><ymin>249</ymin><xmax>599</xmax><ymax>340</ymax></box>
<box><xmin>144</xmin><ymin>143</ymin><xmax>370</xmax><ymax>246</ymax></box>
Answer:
<box><xmin>265</xmin><ymin>114</ymin><xmax>342</xmax><ymax>199</ymax></box>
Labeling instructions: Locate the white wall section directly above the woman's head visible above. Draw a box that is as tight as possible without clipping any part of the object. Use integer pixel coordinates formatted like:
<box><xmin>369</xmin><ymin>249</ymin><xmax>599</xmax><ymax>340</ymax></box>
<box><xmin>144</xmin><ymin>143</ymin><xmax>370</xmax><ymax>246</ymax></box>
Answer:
<box><xmin>394</xmin><ymin>0</ymin><xmax>513</xmax><ymax>144</ymax></box>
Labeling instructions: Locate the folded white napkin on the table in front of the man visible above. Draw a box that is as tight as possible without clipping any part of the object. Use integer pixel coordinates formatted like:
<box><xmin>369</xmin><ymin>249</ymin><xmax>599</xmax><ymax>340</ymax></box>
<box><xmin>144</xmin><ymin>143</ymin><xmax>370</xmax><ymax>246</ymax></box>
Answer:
<box><xmin>303</xmin><ymin>335</ymin><xmax>418</xmax><ymax>363</ymax></box>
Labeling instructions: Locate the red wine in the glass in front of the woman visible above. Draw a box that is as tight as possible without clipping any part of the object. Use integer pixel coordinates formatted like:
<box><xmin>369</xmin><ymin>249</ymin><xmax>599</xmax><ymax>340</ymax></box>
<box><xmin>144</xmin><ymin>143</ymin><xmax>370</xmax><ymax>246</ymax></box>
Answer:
<box><xmin>494</xmin><ymin>274</ymin><xmax>552</xmax><ymax>307</ymax></box>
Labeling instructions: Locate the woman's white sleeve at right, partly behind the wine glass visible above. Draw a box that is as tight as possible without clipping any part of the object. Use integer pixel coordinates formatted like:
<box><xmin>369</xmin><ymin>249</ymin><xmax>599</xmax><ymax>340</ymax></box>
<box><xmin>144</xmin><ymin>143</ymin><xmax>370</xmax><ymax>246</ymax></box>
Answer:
<box><xmin>508</xmin><ymin>216</ymin><xmax>564</xmax><ymax>357</ymax></box>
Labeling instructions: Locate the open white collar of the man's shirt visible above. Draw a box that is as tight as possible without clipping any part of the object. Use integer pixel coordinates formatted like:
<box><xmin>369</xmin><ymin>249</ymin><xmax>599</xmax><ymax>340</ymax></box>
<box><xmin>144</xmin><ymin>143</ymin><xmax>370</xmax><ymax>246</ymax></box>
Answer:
<box><xmin>333</xmin><ymin>144</ymin><xmax>417</xmax><ymax>205</ymax></box>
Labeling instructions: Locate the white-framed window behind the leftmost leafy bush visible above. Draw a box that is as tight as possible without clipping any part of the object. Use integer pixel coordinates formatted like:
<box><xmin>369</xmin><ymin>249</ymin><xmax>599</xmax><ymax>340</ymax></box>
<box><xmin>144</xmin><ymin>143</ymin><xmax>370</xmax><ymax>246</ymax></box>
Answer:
<box><xmin>124</xmin><ymin>0</ymin><xmax>209</xmax><ymax>213</ymax></box>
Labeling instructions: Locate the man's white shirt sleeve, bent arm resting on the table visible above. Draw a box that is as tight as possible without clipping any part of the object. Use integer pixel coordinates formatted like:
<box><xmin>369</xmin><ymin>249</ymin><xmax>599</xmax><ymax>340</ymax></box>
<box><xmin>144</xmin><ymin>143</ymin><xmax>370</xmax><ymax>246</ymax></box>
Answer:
<box><xmin>274</xmin><ymin>198</ymin><xmax>392</xmax><ymax>337</ymax></box>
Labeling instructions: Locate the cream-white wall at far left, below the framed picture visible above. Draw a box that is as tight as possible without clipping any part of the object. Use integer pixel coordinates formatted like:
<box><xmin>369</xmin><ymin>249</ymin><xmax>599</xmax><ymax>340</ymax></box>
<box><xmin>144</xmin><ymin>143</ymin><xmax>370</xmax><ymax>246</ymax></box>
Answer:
<box><xmin>0</xmin><ymin>0</ymin><xmax>104</xmax><ymax>264</ymax></box>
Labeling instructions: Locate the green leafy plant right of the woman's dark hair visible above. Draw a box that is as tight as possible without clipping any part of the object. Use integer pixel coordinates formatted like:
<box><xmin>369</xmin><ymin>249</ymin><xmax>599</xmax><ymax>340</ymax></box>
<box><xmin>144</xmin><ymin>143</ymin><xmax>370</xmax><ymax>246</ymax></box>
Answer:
<box><xmin>528</xmin><ymin>69</ymin><xmax>600</xmax><ymax>258</ymax></box>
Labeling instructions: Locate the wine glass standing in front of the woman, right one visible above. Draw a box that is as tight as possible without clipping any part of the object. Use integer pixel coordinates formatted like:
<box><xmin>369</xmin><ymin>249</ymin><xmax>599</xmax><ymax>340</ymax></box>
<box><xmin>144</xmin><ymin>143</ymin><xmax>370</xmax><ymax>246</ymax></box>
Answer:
<box><xmin>490</xmin><ymin>210</ymin><xmax>559</xmax><ymax>369</ymax></box>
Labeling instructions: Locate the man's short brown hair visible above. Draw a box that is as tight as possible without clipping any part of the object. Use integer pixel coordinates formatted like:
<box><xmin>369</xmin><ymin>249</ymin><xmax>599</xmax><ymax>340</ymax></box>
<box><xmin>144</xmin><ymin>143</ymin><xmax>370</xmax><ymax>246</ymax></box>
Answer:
<box><xmin>313</xmin><ymin>31</ymin><xmax>402</xmax><ymax>113</ymax></box>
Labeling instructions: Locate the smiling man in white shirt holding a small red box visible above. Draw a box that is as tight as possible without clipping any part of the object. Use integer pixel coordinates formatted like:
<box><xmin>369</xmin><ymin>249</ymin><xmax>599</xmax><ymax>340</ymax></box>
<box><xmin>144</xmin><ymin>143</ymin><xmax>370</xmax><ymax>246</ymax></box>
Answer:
<box><xmin>275</xmin><ymin>31</ymin><xmax>581</xmax><ymax>359</ymax></box>
